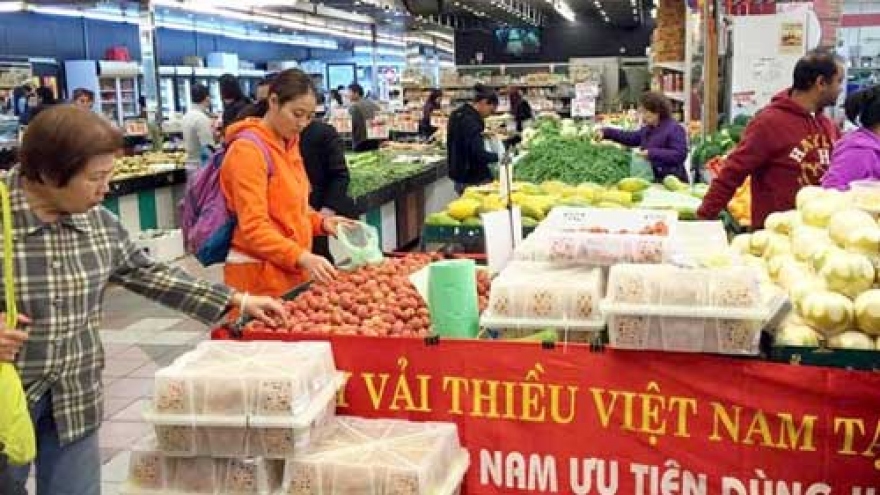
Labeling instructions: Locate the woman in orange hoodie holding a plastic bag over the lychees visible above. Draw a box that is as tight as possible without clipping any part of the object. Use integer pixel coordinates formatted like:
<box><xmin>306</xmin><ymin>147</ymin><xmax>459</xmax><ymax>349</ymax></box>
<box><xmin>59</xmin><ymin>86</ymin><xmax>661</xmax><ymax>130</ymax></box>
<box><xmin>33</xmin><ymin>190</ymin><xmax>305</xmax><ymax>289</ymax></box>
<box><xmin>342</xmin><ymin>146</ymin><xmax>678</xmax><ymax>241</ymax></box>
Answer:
<box><xmin>220</xmin><ymin>69</ymin><xmax>349</xmax><ymax>297</ymax></box>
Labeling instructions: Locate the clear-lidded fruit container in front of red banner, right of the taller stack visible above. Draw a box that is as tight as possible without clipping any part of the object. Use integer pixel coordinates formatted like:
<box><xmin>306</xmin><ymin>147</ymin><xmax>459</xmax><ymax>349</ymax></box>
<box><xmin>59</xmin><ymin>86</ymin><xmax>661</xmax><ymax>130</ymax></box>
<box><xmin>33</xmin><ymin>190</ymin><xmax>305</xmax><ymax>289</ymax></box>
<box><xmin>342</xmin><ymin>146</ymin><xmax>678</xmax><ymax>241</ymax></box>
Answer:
<box><xmin>280</xmin><ymin>417</ymin><xmax>470</xmax><ymax>495</ymax></box>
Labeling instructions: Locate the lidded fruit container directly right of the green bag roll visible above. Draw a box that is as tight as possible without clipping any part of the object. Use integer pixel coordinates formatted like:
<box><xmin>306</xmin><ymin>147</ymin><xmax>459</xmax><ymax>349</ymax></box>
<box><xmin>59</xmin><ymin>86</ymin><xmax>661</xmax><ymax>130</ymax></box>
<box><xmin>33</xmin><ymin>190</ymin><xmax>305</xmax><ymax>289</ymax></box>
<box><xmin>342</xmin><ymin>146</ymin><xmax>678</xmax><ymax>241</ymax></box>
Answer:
<box><xmin>481</xmin><ymin>261</ymin><xmax>604</xmax><ymax>329</ymax></box>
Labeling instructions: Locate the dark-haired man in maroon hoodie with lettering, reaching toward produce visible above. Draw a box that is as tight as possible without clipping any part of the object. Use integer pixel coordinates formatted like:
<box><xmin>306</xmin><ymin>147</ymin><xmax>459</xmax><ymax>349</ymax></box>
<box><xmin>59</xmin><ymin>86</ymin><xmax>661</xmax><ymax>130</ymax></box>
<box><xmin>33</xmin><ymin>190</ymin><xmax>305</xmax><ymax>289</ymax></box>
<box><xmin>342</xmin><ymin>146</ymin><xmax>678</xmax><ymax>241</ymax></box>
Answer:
<box><xmin>697</xmin><ymin>50</ymin><xmax>846</xmax><ymax>229</ymax></box>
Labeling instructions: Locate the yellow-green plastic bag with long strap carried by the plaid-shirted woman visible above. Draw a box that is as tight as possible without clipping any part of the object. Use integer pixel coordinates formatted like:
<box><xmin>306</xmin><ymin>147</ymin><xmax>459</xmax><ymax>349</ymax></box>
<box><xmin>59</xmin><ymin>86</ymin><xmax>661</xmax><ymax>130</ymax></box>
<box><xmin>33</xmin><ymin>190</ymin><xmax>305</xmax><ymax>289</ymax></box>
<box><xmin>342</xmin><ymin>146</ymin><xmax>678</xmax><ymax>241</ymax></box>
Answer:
<box><xmin>0</xmin><ymin>182</ymin><xmax>37</xmax><ymax>466</ymax></box>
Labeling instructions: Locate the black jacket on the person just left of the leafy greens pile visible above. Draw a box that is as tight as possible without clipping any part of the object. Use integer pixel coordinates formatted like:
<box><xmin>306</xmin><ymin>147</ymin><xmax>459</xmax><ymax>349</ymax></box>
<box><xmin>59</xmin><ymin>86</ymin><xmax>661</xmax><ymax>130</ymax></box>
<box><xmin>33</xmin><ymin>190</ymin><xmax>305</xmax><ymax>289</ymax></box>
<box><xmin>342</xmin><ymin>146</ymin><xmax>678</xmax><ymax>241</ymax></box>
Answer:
<box><xmin>446</xmin><ymin>104</ymin><xmax>498</xmax><ymax>184</ymax></box>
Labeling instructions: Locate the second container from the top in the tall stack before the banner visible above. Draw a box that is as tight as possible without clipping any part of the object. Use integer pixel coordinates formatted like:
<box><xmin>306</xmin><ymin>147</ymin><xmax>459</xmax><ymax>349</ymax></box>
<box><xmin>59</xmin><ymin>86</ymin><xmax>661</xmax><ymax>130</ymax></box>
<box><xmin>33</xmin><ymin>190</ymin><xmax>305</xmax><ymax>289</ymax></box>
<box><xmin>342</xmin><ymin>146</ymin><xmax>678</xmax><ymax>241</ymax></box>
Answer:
<box><xmin>144</xmin><ymin>372</ymin><xmax>344</xmax><ymax>459</ymax></box>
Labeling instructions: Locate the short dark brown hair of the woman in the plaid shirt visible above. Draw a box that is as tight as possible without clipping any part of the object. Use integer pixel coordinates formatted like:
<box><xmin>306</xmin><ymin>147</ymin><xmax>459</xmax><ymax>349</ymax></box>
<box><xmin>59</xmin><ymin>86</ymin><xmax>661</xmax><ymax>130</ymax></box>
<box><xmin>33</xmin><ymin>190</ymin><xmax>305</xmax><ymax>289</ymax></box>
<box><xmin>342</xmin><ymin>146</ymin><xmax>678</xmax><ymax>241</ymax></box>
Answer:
<box><xmin>19</xmin><ymin>105</ymin><xmax>122</xmax><ymax>187</ymax></box>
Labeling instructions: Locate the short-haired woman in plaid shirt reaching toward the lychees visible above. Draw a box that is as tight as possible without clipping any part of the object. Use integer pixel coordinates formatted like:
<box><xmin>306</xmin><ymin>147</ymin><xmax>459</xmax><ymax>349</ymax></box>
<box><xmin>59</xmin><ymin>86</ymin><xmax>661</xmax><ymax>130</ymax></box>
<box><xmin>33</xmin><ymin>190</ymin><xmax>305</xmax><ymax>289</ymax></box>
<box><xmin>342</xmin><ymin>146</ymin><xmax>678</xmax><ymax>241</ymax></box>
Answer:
<box><xmin>0</xmin><ymin>105</ymin><xmax>285</xmax><ymax>495</ymax></box>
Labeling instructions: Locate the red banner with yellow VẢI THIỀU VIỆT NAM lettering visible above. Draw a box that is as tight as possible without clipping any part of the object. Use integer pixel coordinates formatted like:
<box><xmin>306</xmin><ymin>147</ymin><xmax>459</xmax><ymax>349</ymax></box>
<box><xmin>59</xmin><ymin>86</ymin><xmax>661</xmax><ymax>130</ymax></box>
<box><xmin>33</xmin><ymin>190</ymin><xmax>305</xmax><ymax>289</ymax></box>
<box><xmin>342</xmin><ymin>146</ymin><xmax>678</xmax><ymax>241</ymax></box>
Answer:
<box><xmin>215</xmin><ymin>337</ymin><xmax>880</xmax><ymax>495</ymax></box>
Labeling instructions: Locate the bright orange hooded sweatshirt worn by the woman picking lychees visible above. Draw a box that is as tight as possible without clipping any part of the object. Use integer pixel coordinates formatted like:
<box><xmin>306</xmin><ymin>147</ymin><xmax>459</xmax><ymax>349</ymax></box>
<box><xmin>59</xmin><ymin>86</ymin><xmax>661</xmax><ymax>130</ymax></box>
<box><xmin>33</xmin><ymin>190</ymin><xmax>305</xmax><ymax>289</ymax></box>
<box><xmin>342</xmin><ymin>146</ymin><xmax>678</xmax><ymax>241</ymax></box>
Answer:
<box><xmin>220</xmin><ymin>118</ymin><xmax>323</xmax><ymax>297</ymax></box>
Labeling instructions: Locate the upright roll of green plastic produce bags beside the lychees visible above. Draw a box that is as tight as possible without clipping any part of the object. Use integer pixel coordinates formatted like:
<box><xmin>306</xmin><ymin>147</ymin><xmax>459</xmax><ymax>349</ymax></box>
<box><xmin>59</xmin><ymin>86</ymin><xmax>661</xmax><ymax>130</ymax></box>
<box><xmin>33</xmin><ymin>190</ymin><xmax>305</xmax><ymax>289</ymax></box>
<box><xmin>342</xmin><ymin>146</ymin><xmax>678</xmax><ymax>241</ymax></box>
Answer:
<box><xmin>428</xmin><ymin>260</ymin><xmax>480</xmax><ymax>338</ymax></box>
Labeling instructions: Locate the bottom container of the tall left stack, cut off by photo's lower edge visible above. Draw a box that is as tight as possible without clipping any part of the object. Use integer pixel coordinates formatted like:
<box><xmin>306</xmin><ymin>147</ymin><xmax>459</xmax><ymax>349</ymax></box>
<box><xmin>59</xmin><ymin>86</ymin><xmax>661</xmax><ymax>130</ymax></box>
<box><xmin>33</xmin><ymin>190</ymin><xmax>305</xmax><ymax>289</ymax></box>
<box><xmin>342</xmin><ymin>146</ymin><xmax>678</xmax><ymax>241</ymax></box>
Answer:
<box><xmin>121</xmin><ymin>437</ymin><xmax>284</xmax><ymax>495</ymax></box>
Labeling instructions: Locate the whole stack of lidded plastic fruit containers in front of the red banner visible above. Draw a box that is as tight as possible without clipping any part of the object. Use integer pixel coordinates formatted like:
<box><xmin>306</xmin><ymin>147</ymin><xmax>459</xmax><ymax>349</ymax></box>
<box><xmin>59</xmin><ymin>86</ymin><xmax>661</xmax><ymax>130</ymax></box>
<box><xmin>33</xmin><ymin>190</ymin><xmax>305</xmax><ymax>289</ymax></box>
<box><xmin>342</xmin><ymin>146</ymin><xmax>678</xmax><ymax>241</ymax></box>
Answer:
<box><xmin>123</xmin><ymin>342</ymin><xmax>468</xmax><ymax>495</ymax></box>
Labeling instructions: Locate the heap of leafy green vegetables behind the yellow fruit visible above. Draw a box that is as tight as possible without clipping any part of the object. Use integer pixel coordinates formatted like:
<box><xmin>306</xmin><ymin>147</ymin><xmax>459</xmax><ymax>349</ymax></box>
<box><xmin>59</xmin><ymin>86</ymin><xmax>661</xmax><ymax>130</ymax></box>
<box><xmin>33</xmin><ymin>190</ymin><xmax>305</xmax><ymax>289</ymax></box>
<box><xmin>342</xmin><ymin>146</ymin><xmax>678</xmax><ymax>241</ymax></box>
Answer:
<box><xmin>513</xmin><ymin>137</ymin><xmax>630</xmax><ymax>185</ymax></box>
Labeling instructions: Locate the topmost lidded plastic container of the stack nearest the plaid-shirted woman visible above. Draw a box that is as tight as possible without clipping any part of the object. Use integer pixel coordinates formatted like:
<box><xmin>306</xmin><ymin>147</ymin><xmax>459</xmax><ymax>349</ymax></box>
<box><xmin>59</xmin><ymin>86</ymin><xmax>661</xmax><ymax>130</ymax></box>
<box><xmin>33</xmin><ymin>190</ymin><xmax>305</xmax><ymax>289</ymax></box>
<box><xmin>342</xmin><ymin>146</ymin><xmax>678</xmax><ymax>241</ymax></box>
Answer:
<box><xmin>152</xmin><ymin>341</ymin><xmax>336</xmax><ymax>419</ymax></box>
